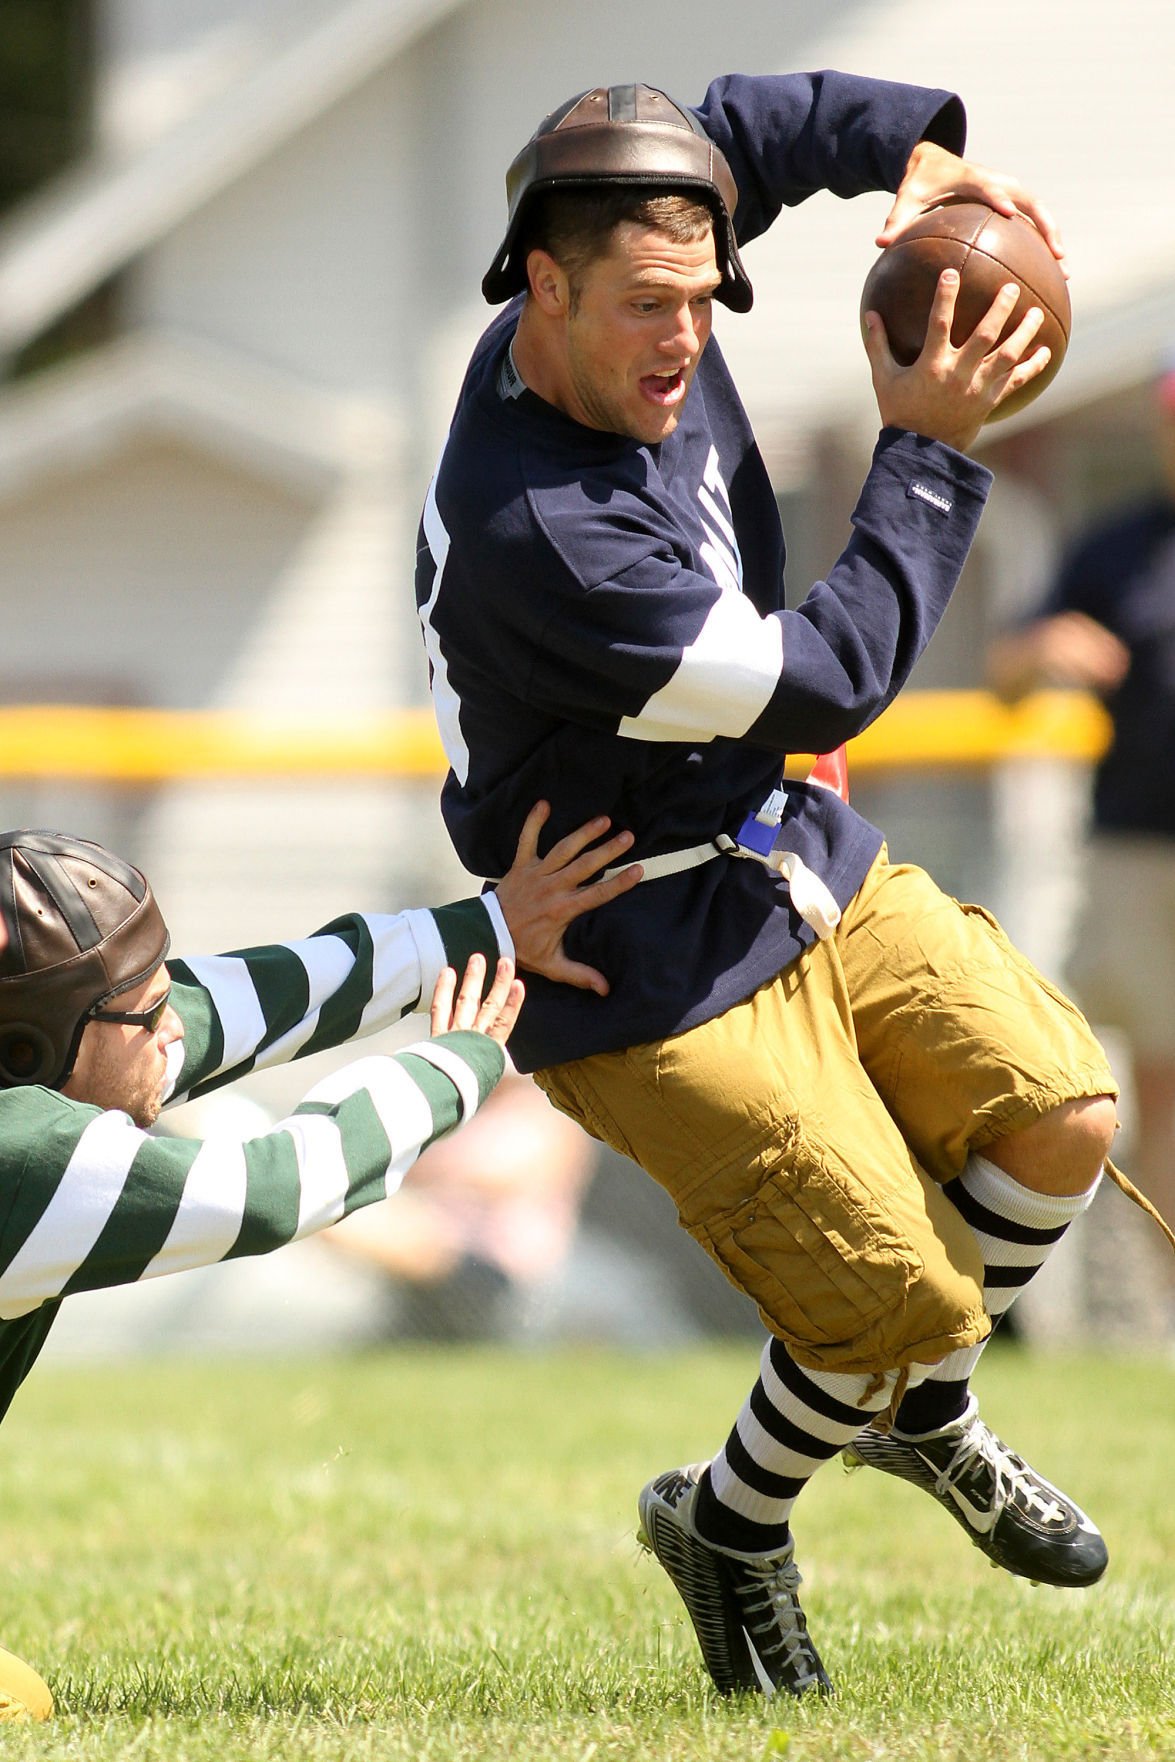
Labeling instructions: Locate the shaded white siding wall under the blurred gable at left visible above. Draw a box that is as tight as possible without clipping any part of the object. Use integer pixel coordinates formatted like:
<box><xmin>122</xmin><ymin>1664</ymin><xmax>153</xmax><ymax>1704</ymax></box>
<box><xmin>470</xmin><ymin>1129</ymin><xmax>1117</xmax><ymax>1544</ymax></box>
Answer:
<box><xmin>0</xmin><ymin>435</ymin><xmax>321</xmax><ymax>707</ymax></box>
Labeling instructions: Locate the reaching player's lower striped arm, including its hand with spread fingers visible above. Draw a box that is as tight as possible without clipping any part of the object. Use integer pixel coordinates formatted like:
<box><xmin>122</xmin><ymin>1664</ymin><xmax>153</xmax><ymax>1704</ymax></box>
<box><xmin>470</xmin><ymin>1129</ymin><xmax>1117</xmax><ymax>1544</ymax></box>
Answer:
<box><xmin>0</xmin><ymin>955</ymin><xmax>521</xmax><ymax>1320</ymax></box>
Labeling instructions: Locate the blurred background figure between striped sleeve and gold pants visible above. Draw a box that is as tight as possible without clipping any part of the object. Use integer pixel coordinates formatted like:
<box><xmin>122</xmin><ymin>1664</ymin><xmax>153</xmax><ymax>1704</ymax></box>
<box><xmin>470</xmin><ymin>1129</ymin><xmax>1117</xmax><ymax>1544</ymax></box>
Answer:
<box><xmin>324</xmin><ymin>1073</ymin><xmax>761</xmax><ymax>1350</ymax></box>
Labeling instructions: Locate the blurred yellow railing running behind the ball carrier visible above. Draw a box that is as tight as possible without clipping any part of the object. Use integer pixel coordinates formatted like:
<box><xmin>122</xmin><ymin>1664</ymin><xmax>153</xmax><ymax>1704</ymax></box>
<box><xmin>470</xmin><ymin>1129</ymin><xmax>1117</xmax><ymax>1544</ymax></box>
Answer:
<box><xmin>0</xmin><ymin>691</ymin><xmax>1108</xmax><ymax>784</ymax></box>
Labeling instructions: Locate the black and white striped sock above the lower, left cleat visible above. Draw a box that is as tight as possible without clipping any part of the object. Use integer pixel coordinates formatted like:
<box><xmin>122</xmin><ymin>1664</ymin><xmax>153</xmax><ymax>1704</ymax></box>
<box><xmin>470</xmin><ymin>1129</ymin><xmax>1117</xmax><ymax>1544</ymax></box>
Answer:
<box><xmin>694</xmin><ymin>1339</ymin><xmax>897</xmax><ymax>1554</ymax></box>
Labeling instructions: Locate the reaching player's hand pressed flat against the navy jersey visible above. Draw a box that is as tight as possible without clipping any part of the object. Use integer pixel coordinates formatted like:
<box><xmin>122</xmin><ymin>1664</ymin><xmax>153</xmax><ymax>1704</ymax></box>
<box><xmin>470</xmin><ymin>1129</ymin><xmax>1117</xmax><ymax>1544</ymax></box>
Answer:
<box><xmin>497</xmin><ymin>802</ymin><xmax>645</xmax><ymax>997</ymax></box>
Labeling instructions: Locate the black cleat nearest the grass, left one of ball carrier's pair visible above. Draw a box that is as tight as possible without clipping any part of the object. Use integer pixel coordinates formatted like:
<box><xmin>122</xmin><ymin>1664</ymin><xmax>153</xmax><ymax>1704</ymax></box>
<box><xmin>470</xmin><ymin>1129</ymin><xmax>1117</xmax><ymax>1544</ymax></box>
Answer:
<box><xmin>638</xmin><ymin>1462</ymin><xmax>831</xmax><ymax>1697</ymax></box>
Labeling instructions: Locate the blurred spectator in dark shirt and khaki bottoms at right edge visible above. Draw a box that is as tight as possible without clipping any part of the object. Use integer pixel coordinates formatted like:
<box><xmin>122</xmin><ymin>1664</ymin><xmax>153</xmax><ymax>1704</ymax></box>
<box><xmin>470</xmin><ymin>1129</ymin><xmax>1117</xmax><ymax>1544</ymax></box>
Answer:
<box><xmin>988</xmin><ymin>361</ymin><xmax>1175</xmax><ymax>1327</ymax></box>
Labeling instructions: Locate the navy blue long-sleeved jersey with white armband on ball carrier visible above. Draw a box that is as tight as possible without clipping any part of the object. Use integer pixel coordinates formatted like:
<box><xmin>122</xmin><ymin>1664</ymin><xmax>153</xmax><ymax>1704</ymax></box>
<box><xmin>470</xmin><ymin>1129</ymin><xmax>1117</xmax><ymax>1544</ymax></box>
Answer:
<box><xmin>418</xmin><ymin>74</ymin><xmax>990</xmax><ymax>1070</ymax></box>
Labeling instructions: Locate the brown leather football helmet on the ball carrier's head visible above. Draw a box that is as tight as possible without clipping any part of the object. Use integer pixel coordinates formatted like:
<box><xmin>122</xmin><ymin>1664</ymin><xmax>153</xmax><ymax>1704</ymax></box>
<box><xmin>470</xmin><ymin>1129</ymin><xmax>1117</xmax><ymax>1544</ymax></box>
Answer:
<box><xmin>481</xmin><ymin>86</ymin><xmax>754</xmax><ymax>312</ymax></box>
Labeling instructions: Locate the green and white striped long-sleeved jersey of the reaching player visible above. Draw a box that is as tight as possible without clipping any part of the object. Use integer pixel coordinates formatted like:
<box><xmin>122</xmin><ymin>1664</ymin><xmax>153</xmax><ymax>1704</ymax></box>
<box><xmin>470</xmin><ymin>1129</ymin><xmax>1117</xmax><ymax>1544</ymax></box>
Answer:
<box><xmin>0</xmin><ymin>895</ymin><xmax>513</xmax><ymax>1418</ymax></box>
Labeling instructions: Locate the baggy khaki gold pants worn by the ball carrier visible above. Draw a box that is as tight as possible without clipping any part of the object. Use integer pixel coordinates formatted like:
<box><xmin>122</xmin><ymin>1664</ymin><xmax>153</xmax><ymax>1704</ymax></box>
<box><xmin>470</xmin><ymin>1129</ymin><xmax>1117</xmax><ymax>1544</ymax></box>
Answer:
<box><xmin>536</xmin><ymin>849</ymin><xmax>1117</xmax><ymax>1373</ymax></box>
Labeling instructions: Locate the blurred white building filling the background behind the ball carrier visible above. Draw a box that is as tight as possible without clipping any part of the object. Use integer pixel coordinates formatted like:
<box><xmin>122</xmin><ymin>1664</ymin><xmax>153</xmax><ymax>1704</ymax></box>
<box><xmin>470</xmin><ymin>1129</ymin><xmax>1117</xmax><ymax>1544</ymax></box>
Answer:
<box><xmin>0</xmin><ymin>0</ymin><xmax>1175</xmax><ymax>1036</ymax></box>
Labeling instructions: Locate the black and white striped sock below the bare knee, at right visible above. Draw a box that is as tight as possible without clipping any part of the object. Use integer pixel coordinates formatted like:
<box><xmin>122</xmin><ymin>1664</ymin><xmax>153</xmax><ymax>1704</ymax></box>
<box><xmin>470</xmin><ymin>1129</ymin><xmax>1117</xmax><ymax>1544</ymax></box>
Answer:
<box><xmin>893</xmin><ymin>1154</ymin><xmax>1101</xmax><ymax>1438</ymax></box>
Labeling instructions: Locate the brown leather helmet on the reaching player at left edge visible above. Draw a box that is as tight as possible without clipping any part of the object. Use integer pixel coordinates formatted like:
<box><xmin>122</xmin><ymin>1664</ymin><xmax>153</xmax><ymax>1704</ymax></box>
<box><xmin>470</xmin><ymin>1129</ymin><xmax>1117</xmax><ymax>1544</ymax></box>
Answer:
<box><xmin>0</xmin><ymin>832</ymin><xmax>169</xmax><ymax>1089</ymax></box>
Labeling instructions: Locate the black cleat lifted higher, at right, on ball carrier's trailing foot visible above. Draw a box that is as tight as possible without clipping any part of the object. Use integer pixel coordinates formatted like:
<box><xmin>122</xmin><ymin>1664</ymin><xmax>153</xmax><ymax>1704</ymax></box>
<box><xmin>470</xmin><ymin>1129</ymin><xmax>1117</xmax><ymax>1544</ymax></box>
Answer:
<box><xmin>842</xmin><ymin>1396</ymin><xmax>1110</xmax><ymax>1588</ymax></box>
